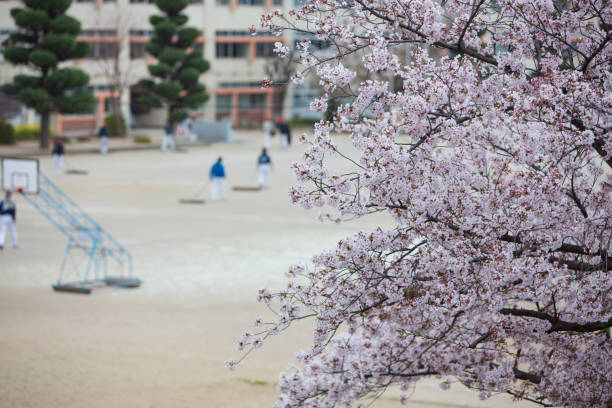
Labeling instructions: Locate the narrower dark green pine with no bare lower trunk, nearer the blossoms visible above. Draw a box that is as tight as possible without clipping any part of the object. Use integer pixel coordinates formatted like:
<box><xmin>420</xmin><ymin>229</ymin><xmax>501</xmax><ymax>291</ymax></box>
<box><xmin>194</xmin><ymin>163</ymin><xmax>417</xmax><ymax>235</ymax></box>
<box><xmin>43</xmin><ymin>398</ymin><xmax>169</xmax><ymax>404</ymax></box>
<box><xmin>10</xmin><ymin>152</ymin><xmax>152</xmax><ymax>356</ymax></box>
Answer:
<box><xmin>138</xmin><ymin>0</ymin><xmax>210</xmax><ymax>126</ymax></box>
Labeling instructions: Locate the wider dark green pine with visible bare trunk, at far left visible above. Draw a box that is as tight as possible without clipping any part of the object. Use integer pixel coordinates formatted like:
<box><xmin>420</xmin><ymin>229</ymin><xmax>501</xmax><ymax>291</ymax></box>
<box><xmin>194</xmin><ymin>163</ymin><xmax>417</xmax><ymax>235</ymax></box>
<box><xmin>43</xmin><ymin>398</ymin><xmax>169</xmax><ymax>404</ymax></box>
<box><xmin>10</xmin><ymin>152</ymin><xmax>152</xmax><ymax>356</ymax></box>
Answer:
<box><xmin>2</xmin><ymin>0</ymin><xmax>94</xmax><ymax>149</ymax></box>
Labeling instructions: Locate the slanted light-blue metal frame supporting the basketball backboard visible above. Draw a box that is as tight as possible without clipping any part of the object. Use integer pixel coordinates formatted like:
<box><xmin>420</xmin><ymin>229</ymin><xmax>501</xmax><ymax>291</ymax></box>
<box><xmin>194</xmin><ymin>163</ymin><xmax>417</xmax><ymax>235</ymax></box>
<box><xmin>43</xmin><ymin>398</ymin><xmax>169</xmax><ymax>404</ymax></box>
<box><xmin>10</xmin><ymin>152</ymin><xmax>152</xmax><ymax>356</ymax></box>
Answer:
<box><xmin>23</xmin><ymin>173</ymin><xmax>140</xmax><ymax>286</ymax></box>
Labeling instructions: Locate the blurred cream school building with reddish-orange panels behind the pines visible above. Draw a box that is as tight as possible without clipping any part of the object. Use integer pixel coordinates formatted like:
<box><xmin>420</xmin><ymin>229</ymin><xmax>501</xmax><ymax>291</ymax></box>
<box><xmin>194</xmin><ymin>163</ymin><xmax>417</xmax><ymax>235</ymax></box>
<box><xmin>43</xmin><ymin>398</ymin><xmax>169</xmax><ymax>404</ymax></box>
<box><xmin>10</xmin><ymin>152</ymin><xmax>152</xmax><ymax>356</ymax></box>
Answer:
<box><xmin>0</xmin><ymin>0</ymin><xmax>317</xmax><ymax>134</ymax></box>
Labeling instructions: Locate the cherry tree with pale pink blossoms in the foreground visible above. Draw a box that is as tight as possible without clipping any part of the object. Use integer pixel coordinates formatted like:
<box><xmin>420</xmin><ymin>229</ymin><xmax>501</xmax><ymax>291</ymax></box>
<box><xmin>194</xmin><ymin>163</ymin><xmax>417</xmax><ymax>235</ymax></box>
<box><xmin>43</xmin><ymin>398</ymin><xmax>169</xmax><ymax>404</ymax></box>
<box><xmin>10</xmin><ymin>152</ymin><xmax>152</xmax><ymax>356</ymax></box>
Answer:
<box><xmin>227</xmin><ymin>0</ymin><xmax>612</xmax><ymax>408</ymax></box>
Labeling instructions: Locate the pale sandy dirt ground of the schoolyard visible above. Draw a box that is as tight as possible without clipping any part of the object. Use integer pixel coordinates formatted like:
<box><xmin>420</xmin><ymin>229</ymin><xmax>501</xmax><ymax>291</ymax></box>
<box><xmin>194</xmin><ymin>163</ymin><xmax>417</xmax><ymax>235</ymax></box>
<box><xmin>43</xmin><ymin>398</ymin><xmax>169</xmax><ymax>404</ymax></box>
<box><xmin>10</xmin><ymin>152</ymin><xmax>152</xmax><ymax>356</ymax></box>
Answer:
<box><xmin>0</xmin><ymin>134</ymin><xmax>530</xmax><ymax>408</ymax></box>
